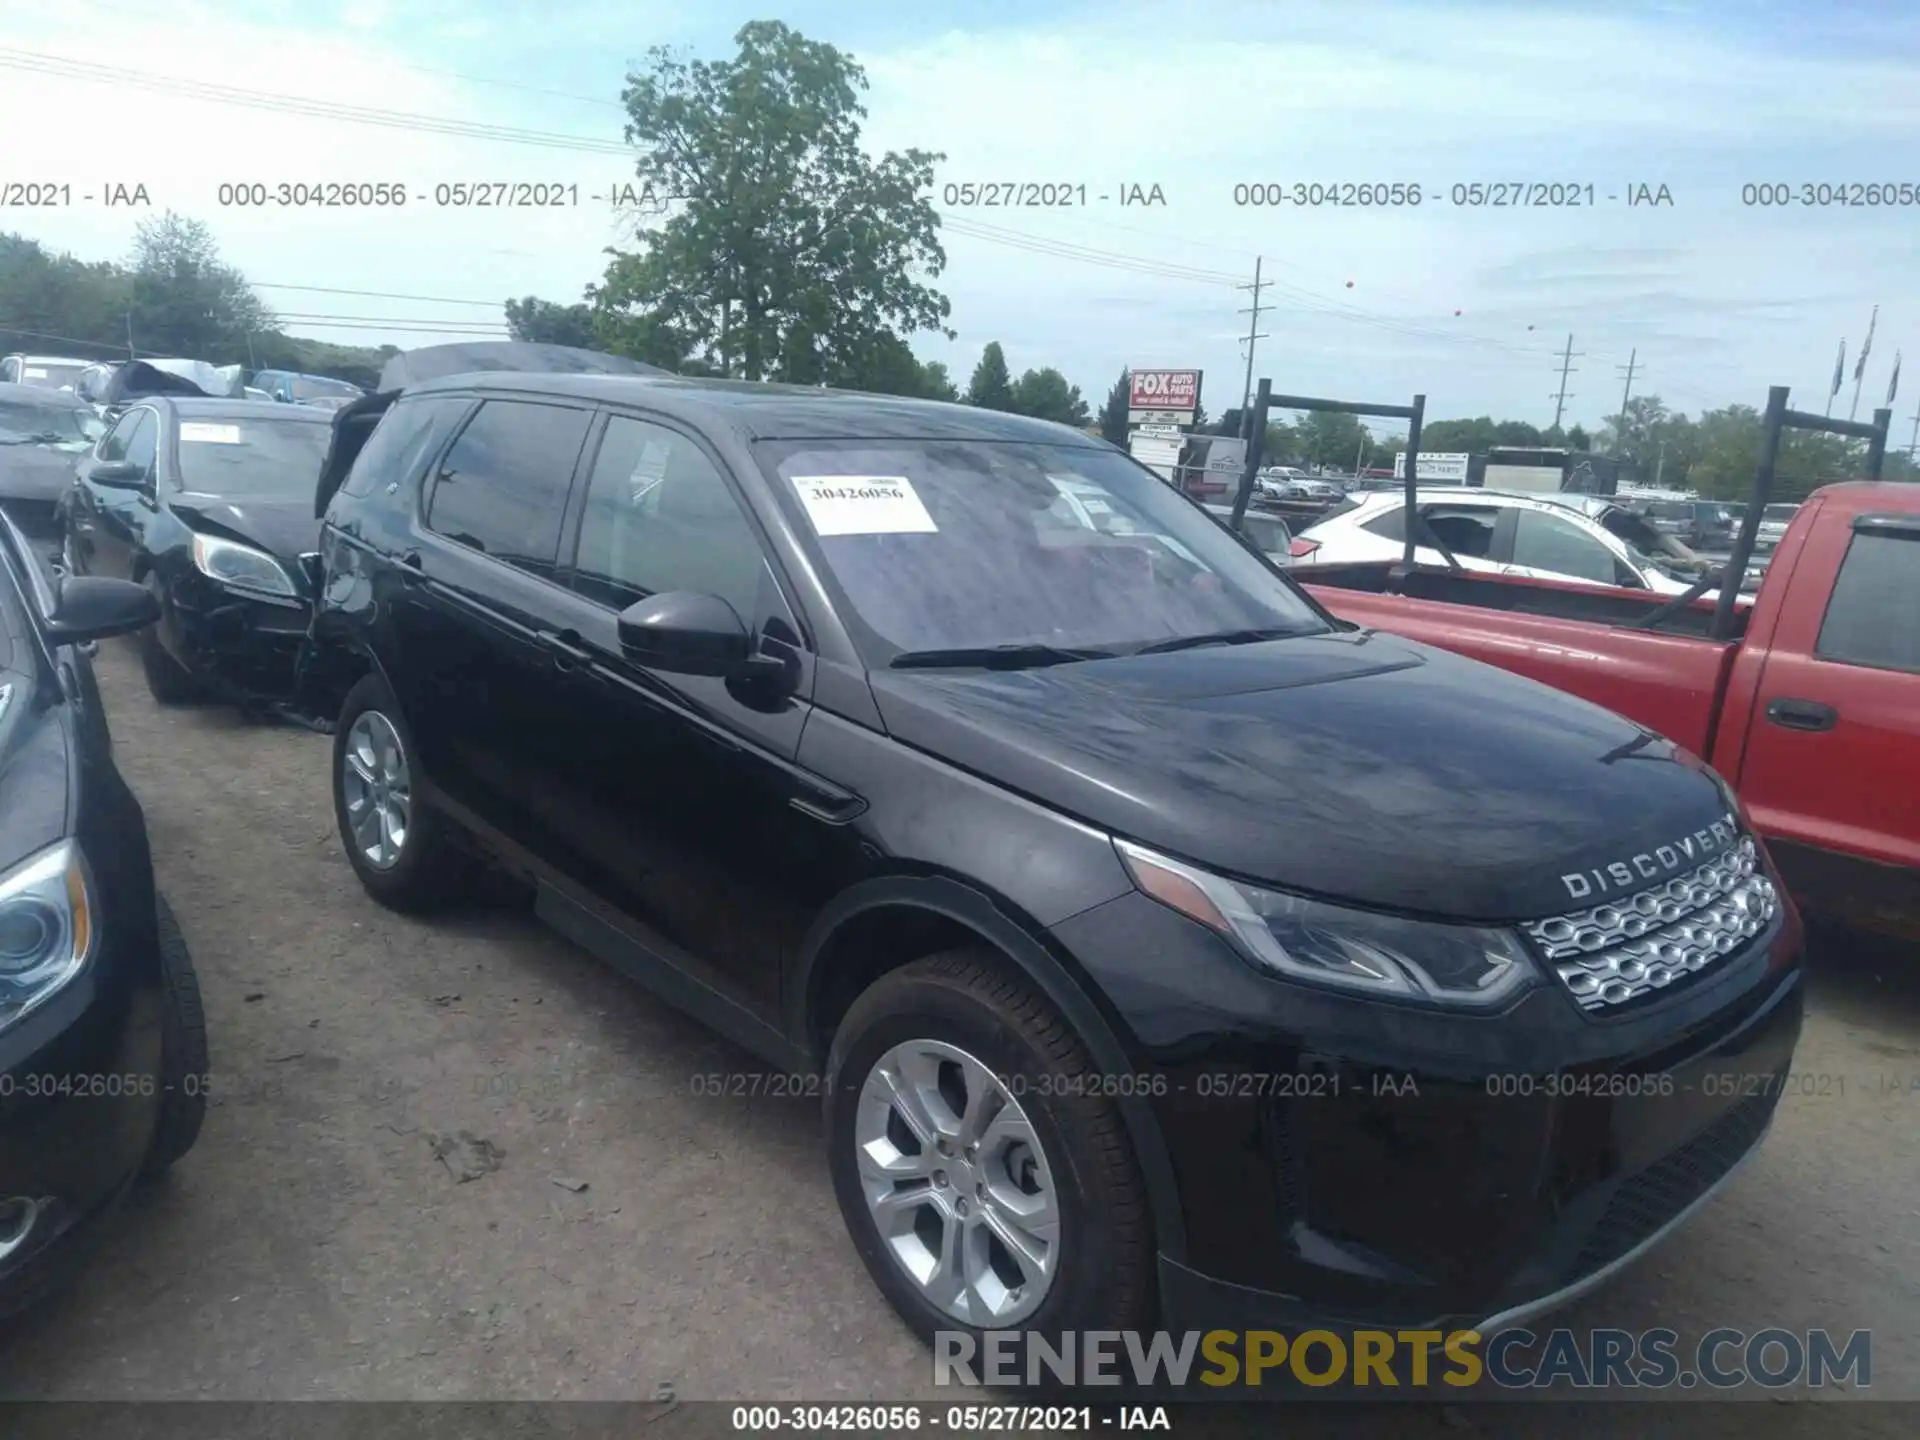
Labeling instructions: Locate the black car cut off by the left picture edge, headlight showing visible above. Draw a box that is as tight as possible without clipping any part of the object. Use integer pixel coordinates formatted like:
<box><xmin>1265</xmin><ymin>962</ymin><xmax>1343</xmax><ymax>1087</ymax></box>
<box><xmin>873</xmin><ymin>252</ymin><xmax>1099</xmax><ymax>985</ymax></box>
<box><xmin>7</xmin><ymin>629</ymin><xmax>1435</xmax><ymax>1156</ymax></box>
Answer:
<box><xmin>0</xmin><ymin>516</ymin><xmax>207</xmax><ymax>1315</ymax></box>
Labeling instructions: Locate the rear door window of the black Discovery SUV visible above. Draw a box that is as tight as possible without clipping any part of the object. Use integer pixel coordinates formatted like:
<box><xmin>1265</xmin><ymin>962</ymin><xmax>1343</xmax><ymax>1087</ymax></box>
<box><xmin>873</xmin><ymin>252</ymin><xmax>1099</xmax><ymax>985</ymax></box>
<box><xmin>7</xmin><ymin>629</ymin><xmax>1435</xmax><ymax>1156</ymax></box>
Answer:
<box><xmin>426</xmin><ymin>399</ymin><xmax>591</xmax><ymax>578</ymax></box>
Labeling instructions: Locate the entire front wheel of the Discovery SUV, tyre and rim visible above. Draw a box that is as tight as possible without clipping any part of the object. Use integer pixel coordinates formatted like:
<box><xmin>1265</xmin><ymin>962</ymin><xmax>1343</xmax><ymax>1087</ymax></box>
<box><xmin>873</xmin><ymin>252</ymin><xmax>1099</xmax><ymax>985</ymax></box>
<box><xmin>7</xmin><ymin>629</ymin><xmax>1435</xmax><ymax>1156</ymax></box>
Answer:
<box><xmin>826</xmin><ymin>948</ymin><xmax>1154</xmax><ymax>1356</ymax></box>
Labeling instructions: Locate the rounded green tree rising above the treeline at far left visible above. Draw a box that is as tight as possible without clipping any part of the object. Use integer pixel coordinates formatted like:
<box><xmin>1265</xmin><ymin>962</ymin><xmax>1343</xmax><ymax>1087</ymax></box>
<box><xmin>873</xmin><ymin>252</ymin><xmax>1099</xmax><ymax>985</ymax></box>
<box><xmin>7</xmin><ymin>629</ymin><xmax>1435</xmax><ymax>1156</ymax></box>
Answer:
<box><xmin>129</xmin><ymin>209</ymin><xmax>276</xmax><ymax>365</ymax></box>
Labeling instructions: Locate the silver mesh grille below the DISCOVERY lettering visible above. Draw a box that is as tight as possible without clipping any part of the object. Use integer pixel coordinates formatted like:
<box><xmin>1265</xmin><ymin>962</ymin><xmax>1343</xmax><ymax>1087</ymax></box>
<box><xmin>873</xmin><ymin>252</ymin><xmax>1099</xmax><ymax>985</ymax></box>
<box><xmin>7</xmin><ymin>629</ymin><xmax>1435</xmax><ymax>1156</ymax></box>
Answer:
<box><xmin>1521</xmin><ymin>837</ymin><xmax>1780</xmax><ymax>1010</ymax></box>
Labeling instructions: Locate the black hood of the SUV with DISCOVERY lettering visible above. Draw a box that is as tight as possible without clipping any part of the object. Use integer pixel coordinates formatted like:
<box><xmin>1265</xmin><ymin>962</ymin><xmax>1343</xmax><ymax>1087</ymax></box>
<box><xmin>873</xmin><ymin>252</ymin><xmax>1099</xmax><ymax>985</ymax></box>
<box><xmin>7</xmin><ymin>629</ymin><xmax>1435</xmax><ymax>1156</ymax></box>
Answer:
<box><xmin>872</xmin><ymin>632</ymin><xmax>1728</xmax><ymax>922</ymax></box>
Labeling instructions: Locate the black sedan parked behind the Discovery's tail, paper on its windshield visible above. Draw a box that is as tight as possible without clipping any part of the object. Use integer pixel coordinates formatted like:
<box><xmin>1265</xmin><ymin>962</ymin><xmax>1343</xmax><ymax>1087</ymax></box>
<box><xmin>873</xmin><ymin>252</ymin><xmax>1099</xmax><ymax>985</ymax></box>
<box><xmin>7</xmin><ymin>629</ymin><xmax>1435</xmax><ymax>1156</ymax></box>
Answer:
<box><xmin>63</xmin><ymin>396</ymin><xmax>330</xmax><ymax>708</ymax></box>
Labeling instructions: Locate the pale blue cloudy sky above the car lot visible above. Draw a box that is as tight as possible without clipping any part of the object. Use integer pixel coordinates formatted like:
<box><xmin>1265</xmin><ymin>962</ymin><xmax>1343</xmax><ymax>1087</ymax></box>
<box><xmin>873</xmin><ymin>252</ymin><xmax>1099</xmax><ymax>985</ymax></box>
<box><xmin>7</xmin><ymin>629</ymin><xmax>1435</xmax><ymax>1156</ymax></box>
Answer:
<box><xmin>0</xmin><ymin>0</ymin><xmax>1920</xmax><ymax>432</ymax></box>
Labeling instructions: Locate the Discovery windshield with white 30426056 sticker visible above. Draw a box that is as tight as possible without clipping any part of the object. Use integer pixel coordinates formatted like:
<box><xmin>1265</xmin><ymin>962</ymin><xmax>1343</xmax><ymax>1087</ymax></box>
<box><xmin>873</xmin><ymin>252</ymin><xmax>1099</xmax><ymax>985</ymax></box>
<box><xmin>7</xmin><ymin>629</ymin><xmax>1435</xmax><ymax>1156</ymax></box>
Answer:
<box><xmin>758</xmin><ymin>440</ymin><xmax>1327</xmax><ymax>664</ymax></box>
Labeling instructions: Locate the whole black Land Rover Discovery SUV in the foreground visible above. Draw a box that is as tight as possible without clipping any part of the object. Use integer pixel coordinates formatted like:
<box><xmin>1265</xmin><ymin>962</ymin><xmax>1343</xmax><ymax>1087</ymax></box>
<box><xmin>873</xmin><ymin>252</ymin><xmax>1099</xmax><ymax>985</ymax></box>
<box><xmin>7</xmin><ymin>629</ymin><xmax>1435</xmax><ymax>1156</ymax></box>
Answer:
<box><xmin>309</xmin><ymin>372</ymin><xmax>1801</xmax><ymax>1334</ymax></box>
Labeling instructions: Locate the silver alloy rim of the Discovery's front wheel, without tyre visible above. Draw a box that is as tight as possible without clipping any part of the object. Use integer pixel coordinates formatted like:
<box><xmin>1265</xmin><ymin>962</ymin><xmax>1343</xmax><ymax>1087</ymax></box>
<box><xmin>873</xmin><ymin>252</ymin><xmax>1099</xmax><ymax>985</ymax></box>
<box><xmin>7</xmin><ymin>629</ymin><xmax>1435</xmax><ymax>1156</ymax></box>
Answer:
<box><xmin>854</xmin><ymin>1041</ymin><xmax>1060</xmax><ymax>1329</ymax></box>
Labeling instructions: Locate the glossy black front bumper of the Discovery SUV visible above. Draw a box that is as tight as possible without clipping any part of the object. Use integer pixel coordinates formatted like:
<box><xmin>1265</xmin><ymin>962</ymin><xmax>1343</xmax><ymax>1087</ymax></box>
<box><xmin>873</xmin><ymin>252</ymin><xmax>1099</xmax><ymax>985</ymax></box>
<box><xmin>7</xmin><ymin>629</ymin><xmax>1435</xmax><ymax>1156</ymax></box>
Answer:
<box><xmin>1056</xmin><ymin>897</ymin><xmax>1803</xmax><ymax>1331</ymax></box>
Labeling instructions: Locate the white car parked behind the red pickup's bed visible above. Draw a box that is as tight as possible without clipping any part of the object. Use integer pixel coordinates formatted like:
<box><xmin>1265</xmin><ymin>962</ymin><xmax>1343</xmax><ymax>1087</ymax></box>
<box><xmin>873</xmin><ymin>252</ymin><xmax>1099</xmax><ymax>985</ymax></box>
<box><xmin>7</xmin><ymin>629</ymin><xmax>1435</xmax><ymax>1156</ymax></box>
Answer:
<box><xmin>1292</xmin><ymin>486</ymin><xmax>1707</xmax><ymax>595</ymax></box>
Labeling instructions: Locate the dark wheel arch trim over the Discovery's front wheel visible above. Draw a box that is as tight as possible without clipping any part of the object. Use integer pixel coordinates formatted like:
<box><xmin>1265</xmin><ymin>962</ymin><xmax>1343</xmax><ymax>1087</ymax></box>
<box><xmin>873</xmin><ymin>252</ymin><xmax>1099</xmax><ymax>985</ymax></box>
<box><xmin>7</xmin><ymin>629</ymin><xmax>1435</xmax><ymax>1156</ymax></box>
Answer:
<box><xmin>787</xmin><ymin>876</ymin><xmax>1187</xmax><ymax>1261</ymax></box>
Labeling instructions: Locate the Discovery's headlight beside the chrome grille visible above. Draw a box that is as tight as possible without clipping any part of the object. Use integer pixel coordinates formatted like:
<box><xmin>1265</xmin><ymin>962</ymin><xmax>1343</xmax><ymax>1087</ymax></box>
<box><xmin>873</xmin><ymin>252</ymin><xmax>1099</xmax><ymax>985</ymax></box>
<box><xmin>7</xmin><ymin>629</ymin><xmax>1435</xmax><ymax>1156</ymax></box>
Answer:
<box><xmin>1114</xmin><ymin>841</ymin><xmax>1538</xmax><ymax>1010</ymax></box>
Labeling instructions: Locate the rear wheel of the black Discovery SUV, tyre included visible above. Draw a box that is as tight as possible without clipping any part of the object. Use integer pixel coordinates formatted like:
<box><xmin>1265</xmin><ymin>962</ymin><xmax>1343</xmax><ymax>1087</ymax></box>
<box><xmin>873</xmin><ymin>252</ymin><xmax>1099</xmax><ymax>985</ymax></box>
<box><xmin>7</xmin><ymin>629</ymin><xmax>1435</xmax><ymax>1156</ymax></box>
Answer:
<box><xmin>334</xmin><ymin>674</ymin><xmax>470</xmax><ymax>914</ymax></box>
